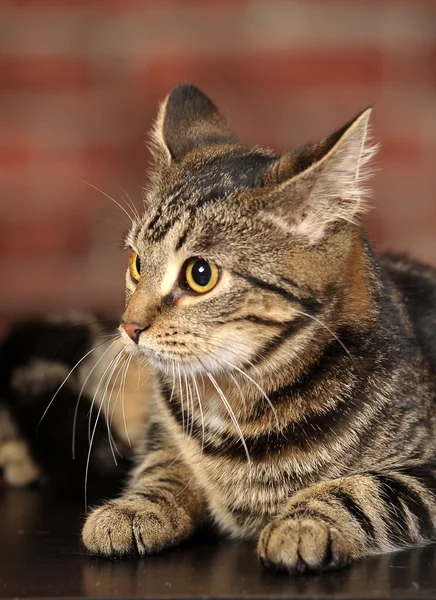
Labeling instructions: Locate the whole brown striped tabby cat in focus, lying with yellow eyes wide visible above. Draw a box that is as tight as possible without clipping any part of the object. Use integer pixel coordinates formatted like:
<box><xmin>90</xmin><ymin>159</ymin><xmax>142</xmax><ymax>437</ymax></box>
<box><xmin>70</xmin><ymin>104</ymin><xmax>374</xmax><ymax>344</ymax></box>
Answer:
<box><xmin>82</xmin><ymin>85</ymin><xmax>436</xmax><ymax>574</ymax></box>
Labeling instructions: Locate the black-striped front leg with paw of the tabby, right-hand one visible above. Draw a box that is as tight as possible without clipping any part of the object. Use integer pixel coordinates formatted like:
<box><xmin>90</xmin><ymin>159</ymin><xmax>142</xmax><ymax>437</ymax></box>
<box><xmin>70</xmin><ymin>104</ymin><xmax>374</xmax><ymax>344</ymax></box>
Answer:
<box><xmin>257</xmin><ymin>467</ymin><xmax>436</xmax><ymax>573</ymax></box>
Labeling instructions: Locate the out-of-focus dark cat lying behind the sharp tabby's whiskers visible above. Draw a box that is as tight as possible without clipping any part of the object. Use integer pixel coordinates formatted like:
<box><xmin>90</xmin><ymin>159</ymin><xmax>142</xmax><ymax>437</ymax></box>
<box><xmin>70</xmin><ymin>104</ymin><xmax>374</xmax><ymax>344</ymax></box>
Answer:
<box><xmin>0</xmin><ymin>312</ymin><xmax>148</xmax><ymax>495</ymax></box>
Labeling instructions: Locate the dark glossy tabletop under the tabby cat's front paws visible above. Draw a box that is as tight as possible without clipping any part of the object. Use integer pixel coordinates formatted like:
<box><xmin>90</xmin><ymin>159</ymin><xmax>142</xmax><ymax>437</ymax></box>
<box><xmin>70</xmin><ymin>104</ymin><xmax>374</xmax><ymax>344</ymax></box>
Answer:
<box><xmin>0</xmin><ymin>489</ymin><xmax>436</xmax><ymax>599</ymax></box>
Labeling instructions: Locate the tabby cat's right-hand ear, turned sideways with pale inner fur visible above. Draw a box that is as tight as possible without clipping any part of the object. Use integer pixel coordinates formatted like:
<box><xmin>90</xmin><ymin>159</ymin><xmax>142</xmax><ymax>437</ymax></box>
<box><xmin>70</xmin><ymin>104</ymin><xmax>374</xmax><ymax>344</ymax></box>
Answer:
<box><xmin>265</xmin><ymin>108</ymin><xmax>377</xmax><ymax>244</ymax></box>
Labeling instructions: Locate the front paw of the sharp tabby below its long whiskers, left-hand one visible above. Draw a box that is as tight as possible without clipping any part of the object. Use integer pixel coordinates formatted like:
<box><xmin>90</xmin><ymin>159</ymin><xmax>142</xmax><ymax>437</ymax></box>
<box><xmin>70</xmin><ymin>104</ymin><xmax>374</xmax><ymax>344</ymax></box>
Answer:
<box><xmin>82</xmin><ymin>498</ymin><xmax>192</xmax><ymax>556</ymax></box>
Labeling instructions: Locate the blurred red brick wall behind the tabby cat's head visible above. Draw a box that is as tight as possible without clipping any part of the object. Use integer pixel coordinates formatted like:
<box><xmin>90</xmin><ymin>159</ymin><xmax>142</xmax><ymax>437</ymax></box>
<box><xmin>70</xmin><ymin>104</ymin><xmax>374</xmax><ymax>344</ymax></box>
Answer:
<box><xmin>0</xmin><ymin>0</ymin><xmax>436</xmax><ymax>322</ymax></box>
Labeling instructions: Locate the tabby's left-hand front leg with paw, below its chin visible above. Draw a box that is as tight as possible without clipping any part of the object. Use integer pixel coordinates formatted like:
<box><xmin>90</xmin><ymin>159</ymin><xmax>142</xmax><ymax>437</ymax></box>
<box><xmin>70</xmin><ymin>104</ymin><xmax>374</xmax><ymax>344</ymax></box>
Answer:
<box><xmin>82</xmin><ymin>450</ymin><xmax>203</xmax><ymax>556</ymax></box>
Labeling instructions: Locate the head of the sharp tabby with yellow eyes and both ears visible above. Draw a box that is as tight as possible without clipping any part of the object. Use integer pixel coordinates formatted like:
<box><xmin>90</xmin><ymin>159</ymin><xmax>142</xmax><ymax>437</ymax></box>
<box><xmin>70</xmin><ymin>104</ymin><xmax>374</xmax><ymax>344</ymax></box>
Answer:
<box><xmin>120</xmin><ymin>85</ymin><xmax>374</xmax><ymax>374</ymax></box>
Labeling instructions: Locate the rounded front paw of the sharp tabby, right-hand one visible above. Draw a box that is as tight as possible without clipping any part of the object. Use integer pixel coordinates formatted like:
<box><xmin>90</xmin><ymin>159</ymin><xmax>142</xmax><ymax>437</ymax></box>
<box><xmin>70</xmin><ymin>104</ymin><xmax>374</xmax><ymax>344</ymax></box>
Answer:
<box><xmin>257</xmin><ymin>516</ymin><xmax>350</xmax><ymax>573</ymax></box>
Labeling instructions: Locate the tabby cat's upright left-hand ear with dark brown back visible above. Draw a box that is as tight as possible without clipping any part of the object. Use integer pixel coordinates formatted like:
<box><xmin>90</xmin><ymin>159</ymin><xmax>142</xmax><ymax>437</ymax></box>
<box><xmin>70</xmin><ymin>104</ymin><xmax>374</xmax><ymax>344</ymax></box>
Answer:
<box><xmin>152</xmin><ymin>84</ymin><xmax>236</xmax><ymax>164</ymax></box>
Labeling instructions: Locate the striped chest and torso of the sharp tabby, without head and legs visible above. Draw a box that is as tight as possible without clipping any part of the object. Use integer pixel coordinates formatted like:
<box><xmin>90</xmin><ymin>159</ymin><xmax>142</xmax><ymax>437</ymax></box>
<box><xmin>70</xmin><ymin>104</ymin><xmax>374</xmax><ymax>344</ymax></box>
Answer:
<box><xmin>156</xmin><ymin>250</ymin><xmax>436</xmax><ymax>547</ymax></box>
